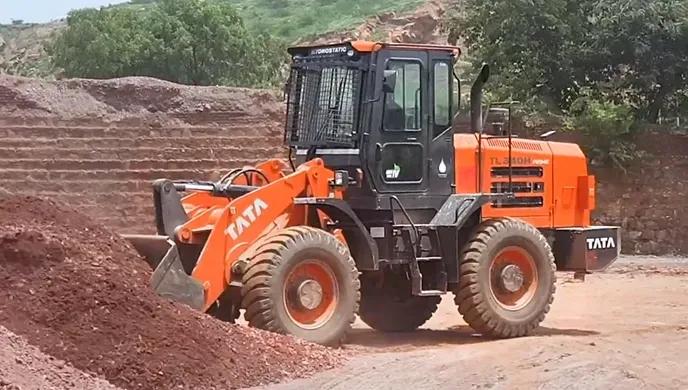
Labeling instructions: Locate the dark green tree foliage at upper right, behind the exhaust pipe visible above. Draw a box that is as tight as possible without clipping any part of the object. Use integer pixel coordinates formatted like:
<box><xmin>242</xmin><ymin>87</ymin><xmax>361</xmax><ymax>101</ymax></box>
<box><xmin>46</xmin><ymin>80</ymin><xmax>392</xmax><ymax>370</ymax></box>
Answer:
<box><xmin>449</xmin><ymin>0</ymin><xmax>688</xmax><ymax>122</ymax></box>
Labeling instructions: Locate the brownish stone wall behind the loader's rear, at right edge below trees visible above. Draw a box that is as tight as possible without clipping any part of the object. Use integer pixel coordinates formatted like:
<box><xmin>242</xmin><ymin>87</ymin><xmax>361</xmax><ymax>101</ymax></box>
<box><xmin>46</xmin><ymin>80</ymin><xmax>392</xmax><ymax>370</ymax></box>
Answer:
<box><xmin>593</xmin><ymin>131</ymin><xmax>688</xmax><ymax>255</ymax></box>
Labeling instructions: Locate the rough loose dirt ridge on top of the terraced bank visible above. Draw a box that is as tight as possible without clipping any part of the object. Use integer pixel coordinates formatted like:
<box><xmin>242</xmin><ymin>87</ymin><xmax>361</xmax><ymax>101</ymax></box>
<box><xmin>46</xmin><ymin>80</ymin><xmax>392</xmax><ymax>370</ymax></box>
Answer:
<box><xmin>0</xmin><ymin>75</ymin><xmax>283</xmax><ymax>127</ymax></box>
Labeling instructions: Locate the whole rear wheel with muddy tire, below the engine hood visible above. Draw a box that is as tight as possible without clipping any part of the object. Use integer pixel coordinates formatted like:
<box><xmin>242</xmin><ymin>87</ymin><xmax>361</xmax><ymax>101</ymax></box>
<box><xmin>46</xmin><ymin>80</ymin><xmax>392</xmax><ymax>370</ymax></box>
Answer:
<box><xmin>454</xmin><ymin>218</ymin><xmax>556</xmax><ymax>338</ymax></box>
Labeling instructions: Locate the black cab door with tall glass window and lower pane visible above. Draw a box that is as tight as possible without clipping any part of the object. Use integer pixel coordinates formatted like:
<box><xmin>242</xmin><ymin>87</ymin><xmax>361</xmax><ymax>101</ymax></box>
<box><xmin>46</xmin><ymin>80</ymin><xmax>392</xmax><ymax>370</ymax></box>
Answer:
<box><xmin>368</xmin><ymin>50</ymin><xmax>430</xmax><ymax>193</ymax></box>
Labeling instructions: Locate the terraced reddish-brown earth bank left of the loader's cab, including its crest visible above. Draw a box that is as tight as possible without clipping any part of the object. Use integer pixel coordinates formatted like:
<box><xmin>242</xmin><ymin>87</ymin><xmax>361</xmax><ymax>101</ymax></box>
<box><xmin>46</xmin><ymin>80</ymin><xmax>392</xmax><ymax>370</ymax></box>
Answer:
<box><xmin>0</xmin><ymin>75</ymin><xmax>286</xmax><ymax>233</ymax></box>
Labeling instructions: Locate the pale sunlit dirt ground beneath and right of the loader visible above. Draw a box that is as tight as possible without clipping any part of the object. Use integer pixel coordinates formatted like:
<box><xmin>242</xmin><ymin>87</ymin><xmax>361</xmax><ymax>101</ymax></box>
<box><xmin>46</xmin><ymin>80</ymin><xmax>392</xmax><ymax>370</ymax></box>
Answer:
<box><xmin>258</xmin><ymin>257</ymin><xmax>688</xmax><ymax>390</ymax></box>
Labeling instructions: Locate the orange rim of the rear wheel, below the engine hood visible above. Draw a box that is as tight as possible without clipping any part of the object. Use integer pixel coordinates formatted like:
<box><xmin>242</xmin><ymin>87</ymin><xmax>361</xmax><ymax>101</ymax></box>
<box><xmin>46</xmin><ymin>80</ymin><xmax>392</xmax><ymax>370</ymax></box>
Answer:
<box><xmin>490</xmin><ymin>246</ymin><xmax>538</xmax><ymax>310</ymax></box>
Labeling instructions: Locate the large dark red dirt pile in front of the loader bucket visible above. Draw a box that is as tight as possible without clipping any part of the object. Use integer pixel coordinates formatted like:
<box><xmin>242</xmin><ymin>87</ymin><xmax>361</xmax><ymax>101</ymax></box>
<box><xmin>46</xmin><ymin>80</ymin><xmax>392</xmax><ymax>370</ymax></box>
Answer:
<box><xmin>0</xmin><ymin>197</ymin><xmax>341</xmax><ymax>389</ymax></box>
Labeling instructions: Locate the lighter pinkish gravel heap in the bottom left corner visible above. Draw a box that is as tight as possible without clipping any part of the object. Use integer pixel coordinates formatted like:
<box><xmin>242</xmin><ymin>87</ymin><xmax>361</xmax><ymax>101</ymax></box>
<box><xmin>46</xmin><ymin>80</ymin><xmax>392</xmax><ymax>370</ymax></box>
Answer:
<box><xmin>0</xmin><ymin>326</ymin><xmax>118</xmax><ymax>390</ymax></box>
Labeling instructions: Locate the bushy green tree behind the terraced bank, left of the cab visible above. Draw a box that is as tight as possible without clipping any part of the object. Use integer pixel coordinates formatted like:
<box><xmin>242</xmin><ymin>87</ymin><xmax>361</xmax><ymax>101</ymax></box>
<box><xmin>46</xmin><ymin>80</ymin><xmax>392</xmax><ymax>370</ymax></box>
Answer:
<box><xmin>49</xmin><ymin>0</ymin><xmax>284</xmax><ymax>86</ymax></box>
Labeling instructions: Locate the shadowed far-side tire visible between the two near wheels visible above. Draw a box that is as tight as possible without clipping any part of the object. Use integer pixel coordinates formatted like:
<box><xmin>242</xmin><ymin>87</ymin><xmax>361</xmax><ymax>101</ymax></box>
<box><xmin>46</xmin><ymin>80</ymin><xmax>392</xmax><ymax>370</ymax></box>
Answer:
<box><xmin>359</xmin><ymin>279</ymin><xmax>441</xmax><ymax>332</ymax></box>
